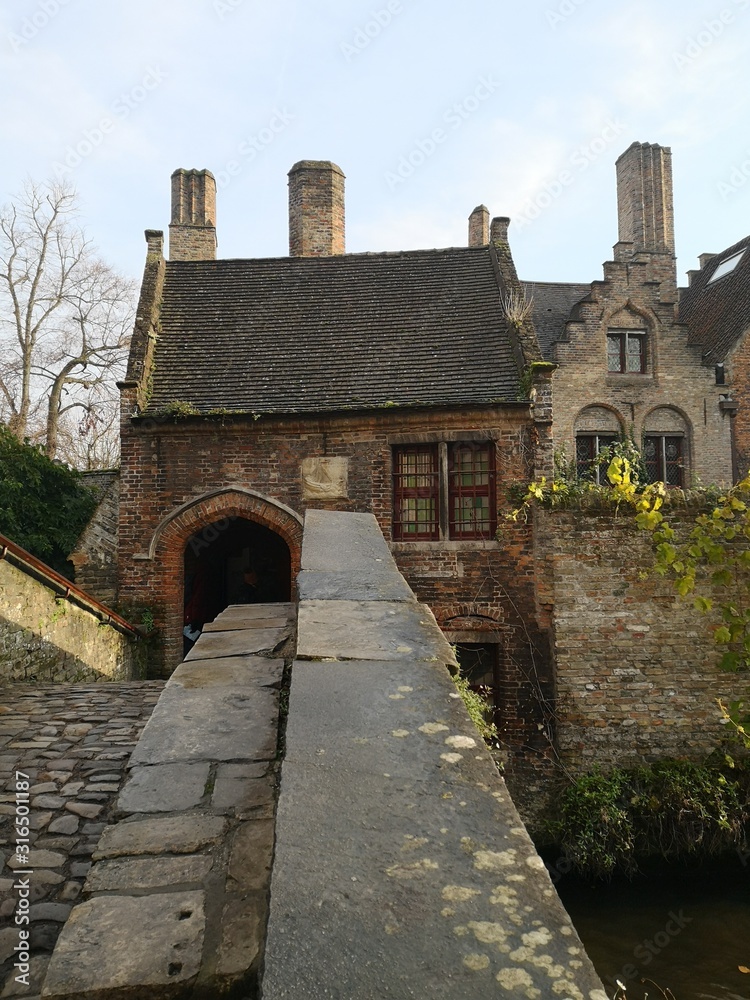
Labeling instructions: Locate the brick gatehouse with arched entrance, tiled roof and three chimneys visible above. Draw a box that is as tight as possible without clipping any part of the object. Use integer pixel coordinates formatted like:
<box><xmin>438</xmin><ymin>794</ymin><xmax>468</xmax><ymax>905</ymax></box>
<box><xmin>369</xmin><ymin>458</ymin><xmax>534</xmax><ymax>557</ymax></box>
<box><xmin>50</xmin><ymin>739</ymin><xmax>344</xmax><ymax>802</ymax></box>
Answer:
<box><xmin>114</xmin><ymin>161</ymin><xmax>551</xmax><ymax>742</ymax></box>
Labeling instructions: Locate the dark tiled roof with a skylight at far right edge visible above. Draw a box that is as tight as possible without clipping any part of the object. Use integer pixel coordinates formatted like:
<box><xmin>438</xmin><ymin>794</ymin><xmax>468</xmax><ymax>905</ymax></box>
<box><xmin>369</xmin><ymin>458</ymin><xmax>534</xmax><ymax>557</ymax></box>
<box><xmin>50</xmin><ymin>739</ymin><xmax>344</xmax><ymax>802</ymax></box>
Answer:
<box><xmin>680</xmin><ymin>236</ymin><xmax>750</xmax><ymax>364</ymax></box>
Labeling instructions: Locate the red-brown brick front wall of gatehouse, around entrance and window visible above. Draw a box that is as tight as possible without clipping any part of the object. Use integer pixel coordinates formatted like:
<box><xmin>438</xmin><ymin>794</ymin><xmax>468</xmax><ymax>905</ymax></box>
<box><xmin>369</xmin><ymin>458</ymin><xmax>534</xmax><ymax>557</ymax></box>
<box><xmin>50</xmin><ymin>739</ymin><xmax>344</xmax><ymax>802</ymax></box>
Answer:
<box><xmin>119</xmin><ymin>398</ymin><xmax>551</xmax><ymax>743</ymax></box>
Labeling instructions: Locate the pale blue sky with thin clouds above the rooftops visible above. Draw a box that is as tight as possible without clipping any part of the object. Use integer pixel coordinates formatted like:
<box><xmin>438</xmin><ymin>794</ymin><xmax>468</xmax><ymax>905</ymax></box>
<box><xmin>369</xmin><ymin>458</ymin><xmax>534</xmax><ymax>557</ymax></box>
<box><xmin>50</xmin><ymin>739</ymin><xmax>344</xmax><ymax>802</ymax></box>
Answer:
<box><xmin>0</xmin><ymin>0</ymin><xmax>750</xmax><ymax>283</ymax></box>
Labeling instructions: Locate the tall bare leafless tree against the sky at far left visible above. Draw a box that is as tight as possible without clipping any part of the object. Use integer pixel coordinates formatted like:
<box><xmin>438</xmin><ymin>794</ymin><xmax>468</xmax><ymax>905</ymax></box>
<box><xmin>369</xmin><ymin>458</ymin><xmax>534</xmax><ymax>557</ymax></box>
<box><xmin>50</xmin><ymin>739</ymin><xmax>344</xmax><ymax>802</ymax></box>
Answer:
<box><xmin>0</xmin><ymin>183</ymin><xmax>135</xmax><ymax>464</ymax></box>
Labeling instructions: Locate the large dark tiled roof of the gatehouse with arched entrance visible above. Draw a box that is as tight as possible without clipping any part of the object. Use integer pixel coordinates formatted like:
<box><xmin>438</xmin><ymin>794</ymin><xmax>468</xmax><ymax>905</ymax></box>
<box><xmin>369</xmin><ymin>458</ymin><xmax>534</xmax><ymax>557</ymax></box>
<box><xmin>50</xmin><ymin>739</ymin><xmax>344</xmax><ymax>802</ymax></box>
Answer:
<box><xmin>144</xmin><ymin>247</ymin><xmax>519</xmax><ymax>413</ymax></box>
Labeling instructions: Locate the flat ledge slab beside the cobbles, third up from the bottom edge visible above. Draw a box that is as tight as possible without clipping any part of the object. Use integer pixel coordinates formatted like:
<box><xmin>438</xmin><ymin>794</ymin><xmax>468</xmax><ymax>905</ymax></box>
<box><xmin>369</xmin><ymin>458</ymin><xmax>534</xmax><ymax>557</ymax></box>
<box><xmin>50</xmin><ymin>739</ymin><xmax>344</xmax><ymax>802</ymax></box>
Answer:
<box><xmin>92</xmin><ymin>812</ymin><xmax>227</xmax><ymax>861</ymax></box>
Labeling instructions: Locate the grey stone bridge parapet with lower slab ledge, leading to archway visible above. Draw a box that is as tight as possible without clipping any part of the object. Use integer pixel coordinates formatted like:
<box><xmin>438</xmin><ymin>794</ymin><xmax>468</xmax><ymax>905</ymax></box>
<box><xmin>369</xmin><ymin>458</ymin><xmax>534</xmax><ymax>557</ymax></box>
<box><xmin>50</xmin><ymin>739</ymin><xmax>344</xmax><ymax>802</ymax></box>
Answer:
<box><xmin>0</xmin><ymin>511</ymin><xmax>606</xmax><ymax>1000</ymax></box>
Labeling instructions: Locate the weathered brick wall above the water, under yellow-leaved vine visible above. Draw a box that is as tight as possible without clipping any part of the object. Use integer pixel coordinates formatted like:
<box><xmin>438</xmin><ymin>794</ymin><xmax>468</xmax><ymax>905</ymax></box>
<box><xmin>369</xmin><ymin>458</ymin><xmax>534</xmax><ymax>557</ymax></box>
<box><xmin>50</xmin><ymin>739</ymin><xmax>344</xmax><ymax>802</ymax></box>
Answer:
<box><xmin>537</xmin><ymin>511</ymin><xmax>747</xmax><ymax>774</ymax></box>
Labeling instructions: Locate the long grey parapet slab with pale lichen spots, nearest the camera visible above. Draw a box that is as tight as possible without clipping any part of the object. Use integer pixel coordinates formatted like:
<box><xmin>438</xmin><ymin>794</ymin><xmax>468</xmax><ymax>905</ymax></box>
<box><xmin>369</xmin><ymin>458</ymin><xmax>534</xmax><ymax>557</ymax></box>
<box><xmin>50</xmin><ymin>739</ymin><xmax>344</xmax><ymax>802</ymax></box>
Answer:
<box><xmin>262</xmin><ymin>660</ymin><xmax>606</xmax><ymax>1000</ymax></box>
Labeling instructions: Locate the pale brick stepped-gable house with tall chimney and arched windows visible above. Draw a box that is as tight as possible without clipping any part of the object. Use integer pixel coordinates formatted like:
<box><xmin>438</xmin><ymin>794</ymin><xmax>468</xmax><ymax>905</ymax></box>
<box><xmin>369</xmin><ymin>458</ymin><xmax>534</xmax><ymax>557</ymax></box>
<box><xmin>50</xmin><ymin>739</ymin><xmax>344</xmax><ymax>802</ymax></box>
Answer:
<box><xmin>524</xmin><ymin>142</ymin><xmax>732</xmax><ymax>486</ymax></box>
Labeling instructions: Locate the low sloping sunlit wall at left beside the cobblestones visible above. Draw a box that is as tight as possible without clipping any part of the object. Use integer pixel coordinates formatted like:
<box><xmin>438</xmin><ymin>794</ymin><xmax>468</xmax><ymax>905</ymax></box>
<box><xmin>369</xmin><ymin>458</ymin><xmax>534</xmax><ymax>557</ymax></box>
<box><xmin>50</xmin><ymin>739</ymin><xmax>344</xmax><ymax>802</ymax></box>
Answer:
<box><xmin>0</xmin><ymin>559</ymin><xmax>145</xmax><ymax>684</ymax></box>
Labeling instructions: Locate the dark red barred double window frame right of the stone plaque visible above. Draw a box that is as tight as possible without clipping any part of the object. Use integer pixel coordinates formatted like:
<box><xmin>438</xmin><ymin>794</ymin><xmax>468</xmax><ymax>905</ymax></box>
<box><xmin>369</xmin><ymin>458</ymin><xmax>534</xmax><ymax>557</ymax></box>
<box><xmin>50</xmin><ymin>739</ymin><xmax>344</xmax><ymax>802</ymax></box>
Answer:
<box><xmin>391</xmin><ymin>436</ymin><xmax>497</xmax><ymax>542</ymax></box>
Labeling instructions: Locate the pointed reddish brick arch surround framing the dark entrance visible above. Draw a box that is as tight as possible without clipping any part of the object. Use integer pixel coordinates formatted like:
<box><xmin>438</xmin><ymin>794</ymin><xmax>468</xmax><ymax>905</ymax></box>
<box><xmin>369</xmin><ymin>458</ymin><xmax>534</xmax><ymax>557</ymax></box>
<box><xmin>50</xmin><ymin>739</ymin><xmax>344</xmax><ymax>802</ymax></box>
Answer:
<box><xmin>145</xmin><ymin>487</ymin><xmax>302</xmax><ymax>671</ymax></box>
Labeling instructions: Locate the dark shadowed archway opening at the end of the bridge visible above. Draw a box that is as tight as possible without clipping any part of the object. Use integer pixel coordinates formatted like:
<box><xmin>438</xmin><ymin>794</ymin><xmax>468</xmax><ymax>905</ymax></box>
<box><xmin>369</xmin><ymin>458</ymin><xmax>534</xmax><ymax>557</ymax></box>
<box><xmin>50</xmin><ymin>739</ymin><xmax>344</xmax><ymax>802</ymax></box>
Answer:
<box><xmin>184</xmin><ymin>517</ymin><xmax>292</xmax><ymax>641</ymax></box>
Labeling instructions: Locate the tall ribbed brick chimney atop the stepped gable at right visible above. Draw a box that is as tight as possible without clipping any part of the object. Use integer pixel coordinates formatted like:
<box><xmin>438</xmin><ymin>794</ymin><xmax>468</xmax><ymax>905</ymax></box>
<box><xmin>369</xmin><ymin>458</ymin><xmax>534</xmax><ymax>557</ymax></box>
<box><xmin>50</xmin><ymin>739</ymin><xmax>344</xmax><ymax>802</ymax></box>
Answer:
<box><xmin>617</xmin><ymin>142</ymin><xmax>674</xmax><ymax>254</ymax></box>
